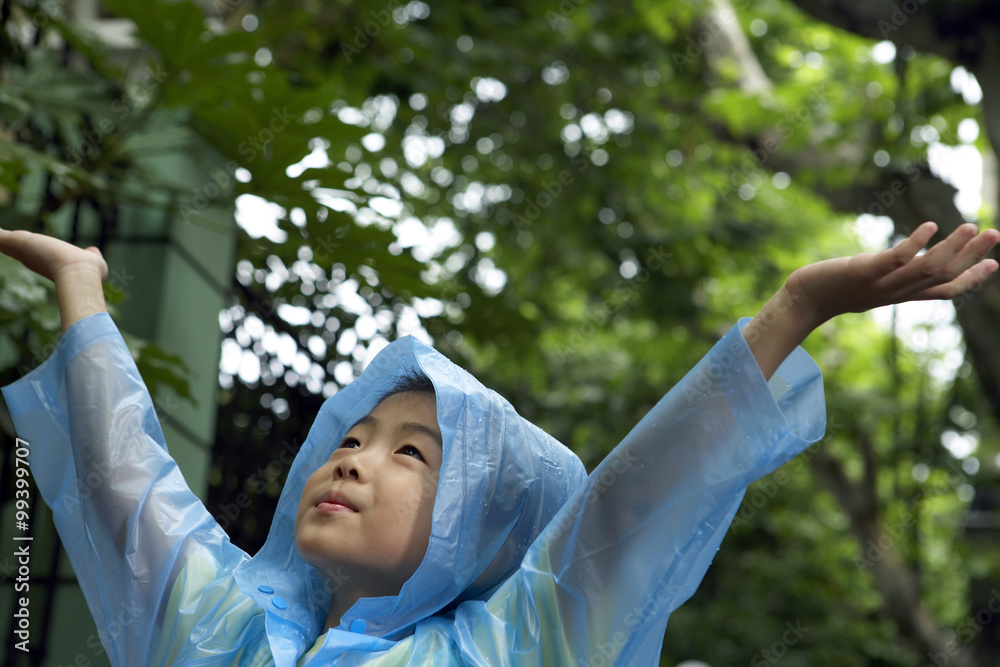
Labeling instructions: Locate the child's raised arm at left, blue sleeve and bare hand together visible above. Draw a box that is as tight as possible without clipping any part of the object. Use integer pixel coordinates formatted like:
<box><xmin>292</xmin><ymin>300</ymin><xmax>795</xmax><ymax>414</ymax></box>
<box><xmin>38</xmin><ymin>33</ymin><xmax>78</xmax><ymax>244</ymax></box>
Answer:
<box><xmin>0</xmin><ymin>230</ymin><xmax>245</xmax><ymax>665</ymax></box>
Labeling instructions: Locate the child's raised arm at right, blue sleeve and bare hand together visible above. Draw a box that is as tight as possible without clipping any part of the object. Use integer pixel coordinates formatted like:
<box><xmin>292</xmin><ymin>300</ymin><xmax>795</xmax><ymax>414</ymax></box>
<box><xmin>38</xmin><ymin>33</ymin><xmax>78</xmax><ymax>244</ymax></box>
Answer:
<box><xmin>470</xmin><ymin>224</ymin><xmax>1000</xmax><ymax>665</ymax></box>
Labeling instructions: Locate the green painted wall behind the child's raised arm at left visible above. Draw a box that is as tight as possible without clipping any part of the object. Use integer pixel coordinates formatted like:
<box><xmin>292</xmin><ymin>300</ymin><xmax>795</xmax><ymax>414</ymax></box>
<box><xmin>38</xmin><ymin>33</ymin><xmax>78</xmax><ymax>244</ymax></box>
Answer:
<box><xmin>0</xmin><ymin>205</ymin><xmax>235</xmax><ymax>667</ymax></box>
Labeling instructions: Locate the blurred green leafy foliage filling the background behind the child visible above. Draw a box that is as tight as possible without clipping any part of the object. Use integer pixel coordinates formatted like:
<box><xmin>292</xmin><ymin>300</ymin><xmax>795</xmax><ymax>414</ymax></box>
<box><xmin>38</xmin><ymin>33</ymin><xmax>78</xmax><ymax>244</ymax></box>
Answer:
<box><xmin>0</xmin><ymin>0</ymin><xmax>1000</xmax><ymax>666</ymax></box>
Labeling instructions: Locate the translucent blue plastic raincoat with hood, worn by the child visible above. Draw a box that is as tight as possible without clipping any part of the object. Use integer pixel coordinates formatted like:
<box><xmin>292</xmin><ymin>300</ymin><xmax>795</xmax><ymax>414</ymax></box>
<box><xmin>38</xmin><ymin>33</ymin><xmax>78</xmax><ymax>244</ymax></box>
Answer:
<box><xmin>4</xmin><ymin>313</ymin><xmax>825</xmax><ymax>667</ymax></box>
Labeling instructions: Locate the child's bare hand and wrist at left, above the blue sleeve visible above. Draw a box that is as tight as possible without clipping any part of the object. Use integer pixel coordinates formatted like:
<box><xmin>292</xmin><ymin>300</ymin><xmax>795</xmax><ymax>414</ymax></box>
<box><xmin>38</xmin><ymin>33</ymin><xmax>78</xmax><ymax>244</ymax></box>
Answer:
<box><xmin>0</xmin><ymin>229</ymin><xmax>108</xmax><ymax>331</ymax></box>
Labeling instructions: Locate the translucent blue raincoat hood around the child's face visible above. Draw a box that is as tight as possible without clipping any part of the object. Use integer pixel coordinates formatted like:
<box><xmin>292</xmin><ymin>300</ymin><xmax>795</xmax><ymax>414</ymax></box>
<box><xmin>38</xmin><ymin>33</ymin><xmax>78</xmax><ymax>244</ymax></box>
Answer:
<box><xmin>235</xmin><ymin>336</ymin><xmax>586</xmax><ymax>655</ymax></box>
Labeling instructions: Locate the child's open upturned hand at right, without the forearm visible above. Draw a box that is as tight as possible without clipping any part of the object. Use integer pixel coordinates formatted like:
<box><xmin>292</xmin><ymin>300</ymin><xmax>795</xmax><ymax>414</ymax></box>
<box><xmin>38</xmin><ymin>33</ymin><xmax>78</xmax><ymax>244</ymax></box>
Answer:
<box><xmin>785</xmin><ymin>222</ymin><xmax>1000</xmax><ymax>327</ymax></box>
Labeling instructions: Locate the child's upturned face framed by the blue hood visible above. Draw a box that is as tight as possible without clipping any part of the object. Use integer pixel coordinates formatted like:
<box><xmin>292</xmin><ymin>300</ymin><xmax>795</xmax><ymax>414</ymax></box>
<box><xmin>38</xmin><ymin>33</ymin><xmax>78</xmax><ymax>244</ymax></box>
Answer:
<box><xmin>295</xmin><ymin>392</ymin><xmax>442</xmax><ymax>596</ymax></box>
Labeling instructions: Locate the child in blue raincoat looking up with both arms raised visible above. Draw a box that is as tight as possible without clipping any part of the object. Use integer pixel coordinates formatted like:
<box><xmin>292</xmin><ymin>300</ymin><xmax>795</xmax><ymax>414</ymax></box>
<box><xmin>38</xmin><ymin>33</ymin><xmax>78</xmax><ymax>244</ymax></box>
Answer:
<box><xmin>0</xmin><ymin>223</ymin><xmax>1000</xmax><ymax>666</ymax></box>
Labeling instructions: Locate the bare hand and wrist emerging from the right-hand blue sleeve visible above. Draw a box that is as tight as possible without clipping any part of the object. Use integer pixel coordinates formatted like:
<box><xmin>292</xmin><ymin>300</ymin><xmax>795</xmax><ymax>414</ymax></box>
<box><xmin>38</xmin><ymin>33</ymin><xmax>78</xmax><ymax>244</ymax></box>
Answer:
<box><xmin>743</xmin><ymin>222</ymin><xmax>1000</xmax><ymax>379</ymax></box>
